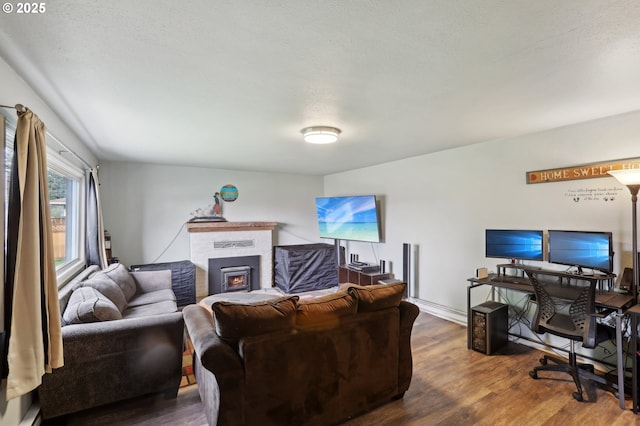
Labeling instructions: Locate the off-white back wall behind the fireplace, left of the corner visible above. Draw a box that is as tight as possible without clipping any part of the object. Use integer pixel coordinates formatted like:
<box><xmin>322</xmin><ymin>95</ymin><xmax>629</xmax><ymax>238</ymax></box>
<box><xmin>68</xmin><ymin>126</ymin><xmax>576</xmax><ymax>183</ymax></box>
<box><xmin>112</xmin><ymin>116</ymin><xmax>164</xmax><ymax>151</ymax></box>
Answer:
<box><xmin>100</xmin><ymin>162</ymin><xmax>323</xmax><ymax>266</ymax></box>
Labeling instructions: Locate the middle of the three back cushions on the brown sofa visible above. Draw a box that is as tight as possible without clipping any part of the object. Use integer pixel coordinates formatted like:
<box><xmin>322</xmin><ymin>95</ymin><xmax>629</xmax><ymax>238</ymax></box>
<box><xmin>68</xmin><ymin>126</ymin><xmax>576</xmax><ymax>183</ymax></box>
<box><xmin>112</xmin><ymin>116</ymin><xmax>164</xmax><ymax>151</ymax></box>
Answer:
<box><xmin>296</xmin><ymin>291</ymin><xmax>358</xmax><ymax>329</ymax></box>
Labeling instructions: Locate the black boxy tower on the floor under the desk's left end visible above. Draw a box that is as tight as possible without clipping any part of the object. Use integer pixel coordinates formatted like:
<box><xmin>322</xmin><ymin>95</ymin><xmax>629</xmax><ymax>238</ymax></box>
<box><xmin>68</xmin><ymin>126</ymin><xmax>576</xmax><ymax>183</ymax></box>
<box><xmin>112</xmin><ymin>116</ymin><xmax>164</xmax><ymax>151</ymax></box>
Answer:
<box><xmin>469</xmin><ymin>301</ymin><xmax>509</xmax><ymax>355</ymax></box>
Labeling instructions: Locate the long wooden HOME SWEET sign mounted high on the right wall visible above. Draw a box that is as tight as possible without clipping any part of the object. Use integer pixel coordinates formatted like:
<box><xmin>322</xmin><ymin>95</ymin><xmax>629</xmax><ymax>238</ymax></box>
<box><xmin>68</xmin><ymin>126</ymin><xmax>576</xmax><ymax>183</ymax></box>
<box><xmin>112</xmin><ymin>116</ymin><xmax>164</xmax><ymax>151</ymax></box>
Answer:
<box><xmin>527</xmin><ymin>158</ymin><xmax>640</xmax><ymax>184</ymax></box>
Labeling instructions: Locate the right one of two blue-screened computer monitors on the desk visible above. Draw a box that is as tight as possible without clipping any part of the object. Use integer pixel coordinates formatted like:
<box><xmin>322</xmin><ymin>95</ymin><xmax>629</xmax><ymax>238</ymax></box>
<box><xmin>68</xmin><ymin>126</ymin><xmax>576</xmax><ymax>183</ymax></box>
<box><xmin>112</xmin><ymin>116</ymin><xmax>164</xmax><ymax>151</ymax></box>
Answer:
<box><xmin>549</xmin><ymin>230</ymin><xmax>613</xmax><ymax>272</ymax></box>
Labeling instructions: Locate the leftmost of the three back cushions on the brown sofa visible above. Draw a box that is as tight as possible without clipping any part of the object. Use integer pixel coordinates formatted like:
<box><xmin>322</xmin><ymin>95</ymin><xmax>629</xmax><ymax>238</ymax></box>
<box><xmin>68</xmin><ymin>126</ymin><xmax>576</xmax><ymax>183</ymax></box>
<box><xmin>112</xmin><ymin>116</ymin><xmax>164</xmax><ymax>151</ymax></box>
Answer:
<box><xmin>211</xmin><ymin>296</ymin><xmax>299</xmax><ymax>344</ymax></box>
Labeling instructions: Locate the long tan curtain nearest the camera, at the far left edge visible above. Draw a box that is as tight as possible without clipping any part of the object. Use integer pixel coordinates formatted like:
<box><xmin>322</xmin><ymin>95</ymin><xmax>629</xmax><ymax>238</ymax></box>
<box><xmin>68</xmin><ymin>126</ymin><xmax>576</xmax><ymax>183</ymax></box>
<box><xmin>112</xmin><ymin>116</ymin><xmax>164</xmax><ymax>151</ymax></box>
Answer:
<box><xmin>5</xmin><ymin>109</ymin><xmax>63</xmax><ymax>400</ymax></box>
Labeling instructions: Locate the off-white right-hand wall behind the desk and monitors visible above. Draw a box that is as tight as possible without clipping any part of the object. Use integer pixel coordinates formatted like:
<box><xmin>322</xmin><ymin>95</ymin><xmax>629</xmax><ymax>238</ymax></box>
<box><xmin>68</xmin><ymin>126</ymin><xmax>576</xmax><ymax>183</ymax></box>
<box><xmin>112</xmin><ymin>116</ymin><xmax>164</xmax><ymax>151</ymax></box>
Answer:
<box><xmin>324</xmin><ymin>112</ymin><xmax>640</xmax><ymax>320</ymax></box>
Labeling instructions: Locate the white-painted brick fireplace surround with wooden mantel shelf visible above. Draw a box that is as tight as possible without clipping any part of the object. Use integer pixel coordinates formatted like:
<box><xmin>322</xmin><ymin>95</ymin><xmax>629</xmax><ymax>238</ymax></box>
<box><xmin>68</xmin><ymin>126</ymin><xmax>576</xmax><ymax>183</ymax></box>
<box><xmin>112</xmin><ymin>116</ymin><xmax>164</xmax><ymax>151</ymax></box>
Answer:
<box><xmin>186</xmin><ymin>222</ymin><xmax>278</xmax><ymax>298</ymax></box>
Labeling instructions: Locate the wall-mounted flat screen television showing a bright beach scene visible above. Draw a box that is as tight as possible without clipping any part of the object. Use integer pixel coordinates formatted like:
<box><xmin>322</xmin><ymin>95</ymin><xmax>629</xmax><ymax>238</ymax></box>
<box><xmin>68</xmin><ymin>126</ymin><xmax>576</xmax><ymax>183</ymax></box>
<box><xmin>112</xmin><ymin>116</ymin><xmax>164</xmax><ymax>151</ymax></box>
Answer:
<box><xmin>316</xmin><ymin>195</ymin><xmax>380</xmax><ymax>243</ymax></box>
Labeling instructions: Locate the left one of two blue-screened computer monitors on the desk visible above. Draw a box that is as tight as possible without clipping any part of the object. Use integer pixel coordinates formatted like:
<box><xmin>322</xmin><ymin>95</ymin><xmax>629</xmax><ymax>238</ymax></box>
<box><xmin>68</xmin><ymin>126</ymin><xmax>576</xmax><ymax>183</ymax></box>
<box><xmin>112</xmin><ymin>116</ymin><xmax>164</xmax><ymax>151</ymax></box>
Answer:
<box><xmin>485</xmin><ymin>229</ymin><xmax>544</xmax><ymax>261</ymax></box>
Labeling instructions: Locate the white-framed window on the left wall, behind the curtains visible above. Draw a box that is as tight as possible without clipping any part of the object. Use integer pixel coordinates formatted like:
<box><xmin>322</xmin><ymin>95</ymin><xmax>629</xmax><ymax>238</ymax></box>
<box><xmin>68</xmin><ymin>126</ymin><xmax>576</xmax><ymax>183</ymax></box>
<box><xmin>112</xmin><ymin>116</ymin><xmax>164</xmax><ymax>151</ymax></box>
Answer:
<box><xmin>4</xmin><ymin>111</ymin><xmax>86</xmax><ymax>285</ymax></box>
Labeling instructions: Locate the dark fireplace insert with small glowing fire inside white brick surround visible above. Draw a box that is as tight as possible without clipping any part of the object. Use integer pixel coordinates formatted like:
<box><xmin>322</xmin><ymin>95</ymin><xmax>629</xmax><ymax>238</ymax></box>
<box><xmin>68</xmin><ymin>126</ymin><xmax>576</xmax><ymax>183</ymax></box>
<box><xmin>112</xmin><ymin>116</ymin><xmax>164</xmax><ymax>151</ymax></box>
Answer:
<box><xmin>208</xmin><ymin>256</ymin><xmax>260</xmax><ymax>294</ymax></box>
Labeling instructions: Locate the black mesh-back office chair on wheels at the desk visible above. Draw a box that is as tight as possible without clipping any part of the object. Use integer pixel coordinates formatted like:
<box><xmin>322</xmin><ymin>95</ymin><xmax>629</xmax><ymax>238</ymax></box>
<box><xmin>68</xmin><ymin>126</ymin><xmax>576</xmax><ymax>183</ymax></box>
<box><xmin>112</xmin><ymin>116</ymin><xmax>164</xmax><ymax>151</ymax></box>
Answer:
<box><xmin>527</xmin><ymin>271</ymin><xmax>611</xmax><ymax>401</ymax></box>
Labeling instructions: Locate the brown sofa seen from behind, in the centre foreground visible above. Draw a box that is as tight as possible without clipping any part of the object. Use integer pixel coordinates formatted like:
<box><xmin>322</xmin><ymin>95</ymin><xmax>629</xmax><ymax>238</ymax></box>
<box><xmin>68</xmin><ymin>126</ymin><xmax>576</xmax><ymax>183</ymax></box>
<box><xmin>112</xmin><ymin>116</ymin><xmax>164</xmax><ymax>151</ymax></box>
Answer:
<box><xmin>183</xmin><ymin>283</ymin><xmax>419</xmax><ymax>425</ymax></box>
